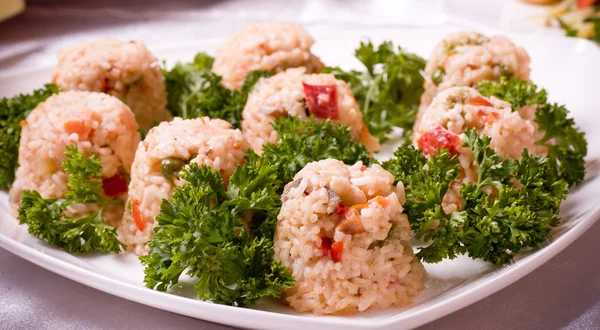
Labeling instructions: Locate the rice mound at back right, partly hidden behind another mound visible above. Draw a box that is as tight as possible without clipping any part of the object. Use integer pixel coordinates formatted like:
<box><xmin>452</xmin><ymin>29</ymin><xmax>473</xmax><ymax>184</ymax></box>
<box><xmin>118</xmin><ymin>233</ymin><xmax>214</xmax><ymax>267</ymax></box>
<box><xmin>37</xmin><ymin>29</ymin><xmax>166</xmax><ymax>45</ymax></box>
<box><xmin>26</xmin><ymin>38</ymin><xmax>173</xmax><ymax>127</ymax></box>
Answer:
<box><xmin>418</xmin><ymin>32</ymin><xmax>531</xmax><ymax>124</ymax></box>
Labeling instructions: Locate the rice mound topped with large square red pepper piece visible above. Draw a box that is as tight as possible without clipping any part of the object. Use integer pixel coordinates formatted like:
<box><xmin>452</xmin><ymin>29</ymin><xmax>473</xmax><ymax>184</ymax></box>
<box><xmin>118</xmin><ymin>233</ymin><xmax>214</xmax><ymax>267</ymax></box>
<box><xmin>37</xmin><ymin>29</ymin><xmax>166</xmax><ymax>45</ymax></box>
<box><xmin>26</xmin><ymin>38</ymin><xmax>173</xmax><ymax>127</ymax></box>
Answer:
<box><xmin>242</xmin><ymin>68</ymin><xmax>380</xmax><ymax>154</ymax></box>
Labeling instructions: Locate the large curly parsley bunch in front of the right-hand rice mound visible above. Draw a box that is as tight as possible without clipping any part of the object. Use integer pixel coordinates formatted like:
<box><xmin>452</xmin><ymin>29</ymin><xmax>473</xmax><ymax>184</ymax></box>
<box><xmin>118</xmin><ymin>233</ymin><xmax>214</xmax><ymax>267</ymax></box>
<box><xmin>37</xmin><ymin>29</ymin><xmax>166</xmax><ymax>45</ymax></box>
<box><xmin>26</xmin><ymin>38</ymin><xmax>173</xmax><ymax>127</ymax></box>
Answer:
<box><xmin>383</xmin><ymin>130</ymin><xmax>568</xmax><ymax>265</ymax></box>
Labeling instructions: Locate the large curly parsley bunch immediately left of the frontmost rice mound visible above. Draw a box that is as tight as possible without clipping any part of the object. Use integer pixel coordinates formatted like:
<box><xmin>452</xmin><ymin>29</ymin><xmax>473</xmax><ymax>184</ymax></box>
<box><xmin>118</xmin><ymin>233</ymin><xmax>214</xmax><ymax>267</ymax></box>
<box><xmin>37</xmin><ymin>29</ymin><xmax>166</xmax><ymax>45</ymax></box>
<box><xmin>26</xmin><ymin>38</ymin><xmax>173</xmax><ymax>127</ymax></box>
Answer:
<box><xmin>140</xmin><ymin>164</ymin><xmax>294</xmax><ymax>307</ymax></box>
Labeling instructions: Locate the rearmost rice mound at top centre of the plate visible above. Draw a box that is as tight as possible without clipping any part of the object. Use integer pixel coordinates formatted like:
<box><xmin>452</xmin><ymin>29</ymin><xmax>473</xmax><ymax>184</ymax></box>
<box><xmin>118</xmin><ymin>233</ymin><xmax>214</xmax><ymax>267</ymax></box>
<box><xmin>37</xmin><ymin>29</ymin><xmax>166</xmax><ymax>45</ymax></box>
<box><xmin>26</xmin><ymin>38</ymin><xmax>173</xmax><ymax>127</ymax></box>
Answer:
<box><xmin>212</xmin><ymin>22</ymin><xmax>323</xmax><ymax>90</ymax></box>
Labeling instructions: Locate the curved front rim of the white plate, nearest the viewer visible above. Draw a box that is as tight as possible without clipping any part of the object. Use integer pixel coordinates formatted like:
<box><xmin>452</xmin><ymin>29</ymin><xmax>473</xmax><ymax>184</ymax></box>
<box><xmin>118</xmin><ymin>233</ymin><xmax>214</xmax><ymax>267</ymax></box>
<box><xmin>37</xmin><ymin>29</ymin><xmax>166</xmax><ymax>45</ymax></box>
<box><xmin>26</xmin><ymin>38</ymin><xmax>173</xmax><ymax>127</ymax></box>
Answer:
<box><xmin>0</xmin><ymin>204</ymin><xmax>600</xmax><ymax>329</ymax></box>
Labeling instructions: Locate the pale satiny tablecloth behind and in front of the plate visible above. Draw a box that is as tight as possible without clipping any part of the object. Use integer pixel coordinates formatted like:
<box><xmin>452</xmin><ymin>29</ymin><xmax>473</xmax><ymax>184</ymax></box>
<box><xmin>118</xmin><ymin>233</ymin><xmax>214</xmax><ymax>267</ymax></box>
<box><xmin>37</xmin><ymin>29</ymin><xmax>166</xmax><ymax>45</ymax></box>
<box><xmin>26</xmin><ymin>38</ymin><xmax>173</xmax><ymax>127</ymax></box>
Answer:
<box><xmin>0</xmin><ymin>0</ymin><xmax>600</xmax><ymax>330</ymax></box>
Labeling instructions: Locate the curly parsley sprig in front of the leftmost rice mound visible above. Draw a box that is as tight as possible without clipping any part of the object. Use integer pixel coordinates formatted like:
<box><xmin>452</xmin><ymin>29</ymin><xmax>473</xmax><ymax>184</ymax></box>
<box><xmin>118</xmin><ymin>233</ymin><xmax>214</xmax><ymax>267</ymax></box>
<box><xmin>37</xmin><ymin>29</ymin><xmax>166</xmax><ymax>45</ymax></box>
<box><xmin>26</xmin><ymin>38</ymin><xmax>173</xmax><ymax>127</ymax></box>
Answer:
<box><xmin>17</xmin><ymin>146</ymin><xmax>124</xmax><ymax>253</ymax></box>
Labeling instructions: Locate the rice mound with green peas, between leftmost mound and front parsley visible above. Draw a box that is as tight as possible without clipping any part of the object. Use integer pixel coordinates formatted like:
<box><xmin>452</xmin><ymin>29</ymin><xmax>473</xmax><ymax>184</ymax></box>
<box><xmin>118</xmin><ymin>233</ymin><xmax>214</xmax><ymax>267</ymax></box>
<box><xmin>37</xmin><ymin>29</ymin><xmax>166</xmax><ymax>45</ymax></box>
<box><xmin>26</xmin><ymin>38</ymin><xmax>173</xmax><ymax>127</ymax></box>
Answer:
<box><xmin>118</xmin><ymin>117</ymin><xmax>250</xmax><ymax>255</ymax></box>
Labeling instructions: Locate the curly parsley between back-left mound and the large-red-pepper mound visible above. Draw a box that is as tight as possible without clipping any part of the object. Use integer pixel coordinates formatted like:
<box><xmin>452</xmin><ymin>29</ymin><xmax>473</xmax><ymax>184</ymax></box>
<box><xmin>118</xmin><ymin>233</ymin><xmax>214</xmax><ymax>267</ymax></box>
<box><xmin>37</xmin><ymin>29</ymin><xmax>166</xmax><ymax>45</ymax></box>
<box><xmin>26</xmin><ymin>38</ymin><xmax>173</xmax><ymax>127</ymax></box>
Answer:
<box><xmin>163</xmin><ymin>53</ymin><xmax>270</xmax><ymax>128</ymax></box>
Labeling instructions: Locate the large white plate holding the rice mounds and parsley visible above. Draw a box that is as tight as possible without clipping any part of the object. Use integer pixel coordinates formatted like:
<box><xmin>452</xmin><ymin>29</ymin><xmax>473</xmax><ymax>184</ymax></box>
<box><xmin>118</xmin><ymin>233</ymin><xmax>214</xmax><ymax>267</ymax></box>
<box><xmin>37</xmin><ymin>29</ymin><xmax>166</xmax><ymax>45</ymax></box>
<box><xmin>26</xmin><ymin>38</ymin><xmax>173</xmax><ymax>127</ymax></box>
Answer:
<box><xmin>0</xmin><ymin>28</ymin><xmax>600</xmax><ymax>330</ymax></box>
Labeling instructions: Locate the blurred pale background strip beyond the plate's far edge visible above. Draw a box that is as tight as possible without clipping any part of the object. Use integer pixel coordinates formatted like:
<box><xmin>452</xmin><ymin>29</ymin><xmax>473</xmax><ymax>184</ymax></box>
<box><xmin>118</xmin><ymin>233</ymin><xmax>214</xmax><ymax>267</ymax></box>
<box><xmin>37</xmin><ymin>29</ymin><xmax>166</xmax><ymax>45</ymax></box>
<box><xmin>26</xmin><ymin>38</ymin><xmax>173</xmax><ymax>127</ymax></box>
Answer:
<box><xmin>0</xmin><ymin>0</ymin><xmax>589</xmax><ymax>72</ymax></box>
